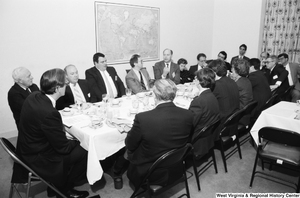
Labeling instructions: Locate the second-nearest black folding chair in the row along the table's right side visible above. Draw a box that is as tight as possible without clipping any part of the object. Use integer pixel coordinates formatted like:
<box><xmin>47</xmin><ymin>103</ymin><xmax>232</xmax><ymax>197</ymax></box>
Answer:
<box><xmin>192</xmin><ymin>120</ymin><xmax>220</xmax><ymax>191</ymax></box>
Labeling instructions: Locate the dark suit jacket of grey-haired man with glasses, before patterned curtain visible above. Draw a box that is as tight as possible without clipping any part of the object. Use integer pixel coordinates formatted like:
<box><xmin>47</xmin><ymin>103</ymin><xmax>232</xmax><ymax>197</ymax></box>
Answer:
<box><xmin>268</xmin><ymin>64</ymin><xmax>289</xmax><ymax>95</ymax></box>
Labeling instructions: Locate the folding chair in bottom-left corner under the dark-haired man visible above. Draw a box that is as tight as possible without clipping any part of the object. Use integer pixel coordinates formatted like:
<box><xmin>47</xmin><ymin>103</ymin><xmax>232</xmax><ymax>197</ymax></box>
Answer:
<box><xmin>0</xmin><ymin>137</ymin><xmax>67</xmax><ymax>198</ymax></box>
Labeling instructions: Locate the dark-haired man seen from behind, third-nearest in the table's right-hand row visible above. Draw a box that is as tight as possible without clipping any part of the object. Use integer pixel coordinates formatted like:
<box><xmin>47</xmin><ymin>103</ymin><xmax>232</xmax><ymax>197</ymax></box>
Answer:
<box><xmin>208</xmin><ymin>59</ymin><xmax>240</xmax><ymax>127</ymax></box>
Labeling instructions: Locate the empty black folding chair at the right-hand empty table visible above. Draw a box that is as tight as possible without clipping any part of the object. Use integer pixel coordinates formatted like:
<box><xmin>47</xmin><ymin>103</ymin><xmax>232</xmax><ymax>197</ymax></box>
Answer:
<box><xmin>250</xmin><ymin>127</ymin><xmax>300</xmax><ymax>193</ymax></box>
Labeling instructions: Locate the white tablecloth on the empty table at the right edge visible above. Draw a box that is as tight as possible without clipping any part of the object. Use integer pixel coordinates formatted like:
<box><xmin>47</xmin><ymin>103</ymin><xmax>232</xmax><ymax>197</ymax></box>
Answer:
<box><xmin>250</xmin><ymin>102</ymin><xmax>300</xmax><ymax>144</ymax></box>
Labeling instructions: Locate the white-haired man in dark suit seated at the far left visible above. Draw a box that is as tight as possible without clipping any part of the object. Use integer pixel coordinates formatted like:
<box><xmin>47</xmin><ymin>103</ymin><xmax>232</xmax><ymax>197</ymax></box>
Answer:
<box><xmin>7</xmin><ymin>67</ymin><xmax>39</xmax><ymax>129</ymax></box>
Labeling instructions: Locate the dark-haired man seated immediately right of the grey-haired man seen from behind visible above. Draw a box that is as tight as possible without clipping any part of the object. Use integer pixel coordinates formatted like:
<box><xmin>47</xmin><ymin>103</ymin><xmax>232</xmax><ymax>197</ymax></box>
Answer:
<box><xmin>189</xmin><ymin>68</ymin><xmax>220</xmax><ymax>156</ymax></box>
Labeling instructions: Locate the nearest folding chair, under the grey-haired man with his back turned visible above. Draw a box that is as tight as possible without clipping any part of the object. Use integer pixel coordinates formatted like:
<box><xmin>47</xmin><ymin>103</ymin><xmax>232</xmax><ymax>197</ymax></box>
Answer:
<box><xmin>131</xmin><ymin>143</ymin><xmax>192</xmax><ymax>197</ymax></box>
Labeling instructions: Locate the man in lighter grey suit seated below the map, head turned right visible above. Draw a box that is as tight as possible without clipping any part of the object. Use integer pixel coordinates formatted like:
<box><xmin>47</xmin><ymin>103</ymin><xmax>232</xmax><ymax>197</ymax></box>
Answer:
<box><xmin>125</xmin><ymin>54</ymin><xmax>150</xmax><ymax>94</ymax></box>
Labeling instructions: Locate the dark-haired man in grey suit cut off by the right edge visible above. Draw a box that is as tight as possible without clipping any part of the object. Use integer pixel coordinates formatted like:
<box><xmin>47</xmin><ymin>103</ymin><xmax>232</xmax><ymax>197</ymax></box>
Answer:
<box><xmin>278</xmin><ymin>53</ymin><xmax>300</xmax><ymax>102</ymax></box>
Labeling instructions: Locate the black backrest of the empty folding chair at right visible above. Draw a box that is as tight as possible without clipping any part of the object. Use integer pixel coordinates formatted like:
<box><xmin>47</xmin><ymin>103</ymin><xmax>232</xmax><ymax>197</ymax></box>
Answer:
<box><xmin>258</xmin><ymin>127</ymin><xmax>300</xmax><ymax>147</ymax></box>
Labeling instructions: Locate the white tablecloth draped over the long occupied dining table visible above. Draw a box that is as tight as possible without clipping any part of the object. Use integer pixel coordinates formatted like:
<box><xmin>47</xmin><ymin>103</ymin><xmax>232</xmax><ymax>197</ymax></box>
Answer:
<box><xmin>62</xmin><ymin>93</ymin><xmax>191</xmax><ymax>184</ymax></box>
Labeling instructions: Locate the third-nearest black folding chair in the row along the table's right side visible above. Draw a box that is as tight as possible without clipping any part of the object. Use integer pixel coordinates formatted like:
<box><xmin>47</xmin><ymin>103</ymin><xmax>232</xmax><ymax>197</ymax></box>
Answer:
<box><xmin>217</xmin><ymin>109</ymin><xmax>245</xmax><ymax>172</ymax></box>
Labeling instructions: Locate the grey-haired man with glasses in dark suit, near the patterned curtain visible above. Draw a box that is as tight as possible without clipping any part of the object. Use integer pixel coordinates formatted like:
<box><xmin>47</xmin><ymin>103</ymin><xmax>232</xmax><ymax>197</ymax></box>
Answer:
<box><xmin>266</xmin><ymin>55</ymin><xmax>289</xmax><ymax>96</ymax></box>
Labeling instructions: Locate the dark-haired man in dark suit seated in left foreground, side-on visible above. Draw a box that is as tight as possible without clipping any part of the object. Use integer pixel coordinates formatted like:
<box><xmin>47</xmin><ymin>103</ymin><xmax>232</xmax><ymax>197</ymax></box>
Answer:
<box><xmin>17</xmin><ymin>69</ymin><xmax>89</xmax><ymax>198</ymax></box>
